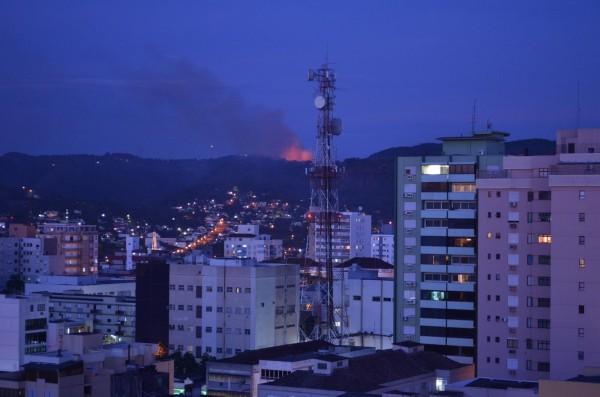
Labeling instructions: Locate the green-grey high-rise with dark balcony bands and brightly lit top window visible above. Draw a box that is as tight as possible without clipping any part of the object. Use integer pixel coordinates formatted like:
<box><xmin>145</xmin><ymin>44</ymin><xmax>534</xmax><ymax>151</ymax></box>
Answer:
<box><xmin>394</xmin><ymin>131</ymin><xmax>508</xmax><ymax>364</ymax></box>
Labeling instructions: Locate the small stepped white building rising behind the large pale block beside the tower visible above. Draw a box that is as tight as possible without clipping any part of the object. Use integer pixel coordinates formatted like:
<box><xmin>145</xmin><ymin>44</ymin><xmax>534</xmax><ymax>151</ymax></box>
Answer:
<box><xmin>224</xmin><ymin>225</ymin><xmax>283</xmax><ymax>262</ymax></box>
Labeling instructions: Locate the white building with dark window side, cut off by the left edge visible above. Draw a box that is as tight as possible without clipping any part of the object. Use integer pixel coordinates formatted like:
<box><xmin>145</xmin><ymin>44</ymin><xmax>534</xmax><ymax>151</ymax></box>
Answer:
<box><xmin>0</xmin><ymin>295</ymin><xmax>48</xmax><ymax>371</ymax></box>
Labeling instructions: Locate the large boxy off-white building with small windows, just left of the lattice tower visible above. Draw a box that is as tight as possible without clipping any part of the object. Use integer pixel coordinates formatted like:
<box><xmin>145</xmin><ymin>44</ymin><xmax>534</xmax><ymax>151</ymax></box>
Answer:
<box><xmin>169</xmin><ymin>258</ymin><xmax>300</xmax><ymax>359</ymax></box>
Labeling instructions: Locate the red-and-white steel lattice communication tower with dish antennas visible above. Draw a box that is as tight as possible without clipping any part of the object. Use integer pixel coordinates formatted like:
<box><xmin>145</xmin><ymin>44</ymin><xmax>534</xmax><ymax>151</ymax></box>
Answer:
<box><xmin>301</xmin><ymin>62</ymin><xmax>347</xmax><ymax>342</ymax></box>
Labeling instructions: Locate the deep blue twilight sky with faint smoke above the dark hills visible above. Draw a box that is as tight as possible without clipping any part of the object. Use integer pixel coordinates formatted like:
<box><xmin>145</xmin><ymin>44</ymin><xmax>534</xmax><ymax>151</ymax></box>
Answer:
<box><xmin>0</xmin><ymin>0</ymin><xmax>600</xmax><ymax>159</ymax></box>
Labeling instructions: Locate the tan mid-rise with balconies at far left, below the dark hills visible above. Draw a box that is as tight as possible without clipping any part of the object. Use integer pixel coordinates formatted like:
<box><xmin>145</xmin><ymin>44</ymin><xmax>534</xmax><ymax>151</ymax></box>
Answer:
<box><xmin>37</xmin><ymin>223</ymin><xmax>98</xmax><ymax>275</ymax></box>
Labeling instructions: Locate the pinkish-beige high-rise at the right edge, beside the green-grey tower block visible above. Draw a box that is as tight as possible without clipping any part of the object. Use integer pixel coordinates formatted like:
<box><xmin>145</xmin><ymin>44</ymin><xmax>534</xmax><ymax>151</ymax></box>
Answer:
<box><xmin>477</xmin><ymin>129</ymin><xmax>600</xmax><ymax>380</ymax></box>
